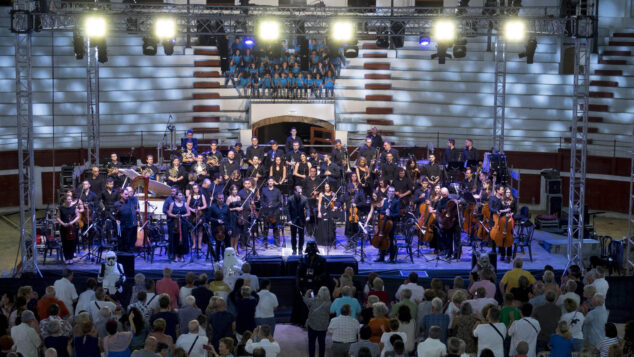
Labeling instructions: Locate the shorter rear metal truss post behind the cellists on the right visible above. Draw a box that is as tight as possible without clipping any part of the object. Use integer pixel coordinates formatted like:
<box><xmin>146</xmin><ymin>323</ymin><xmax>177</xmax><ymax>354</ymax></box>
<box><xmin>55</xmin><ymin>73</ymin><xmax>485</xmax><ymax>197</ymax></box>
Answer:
<box><xmin>493</xmin><ymin>34</ymin><xmax>506</xmax><ymax>152</ymax></box>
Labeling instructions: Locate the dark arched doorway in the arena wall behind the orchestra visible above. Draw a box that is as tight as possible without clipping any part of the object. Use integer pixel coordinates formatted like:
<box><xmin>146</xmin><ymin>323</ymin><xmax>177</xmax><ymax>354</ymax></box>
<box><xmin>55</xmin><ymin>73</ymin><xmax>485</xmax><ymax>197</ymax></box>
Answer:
<box><xmin>251</xmin><ymin>115</ymin><xmax>335</xmax><ymax>152</ymax></box>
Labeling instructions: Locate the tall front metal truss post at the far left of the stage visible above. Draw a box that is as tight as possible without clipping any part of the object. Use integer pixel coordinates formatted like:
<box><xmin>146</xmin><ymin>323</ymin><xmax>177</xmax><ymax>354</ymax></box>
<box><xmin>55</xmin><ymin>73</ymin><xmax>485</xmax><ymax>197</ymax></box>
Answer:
<box><xmin>11</xmin><ymin>0</ymin><xmax>42</xmax><ymax>276</ymax></box>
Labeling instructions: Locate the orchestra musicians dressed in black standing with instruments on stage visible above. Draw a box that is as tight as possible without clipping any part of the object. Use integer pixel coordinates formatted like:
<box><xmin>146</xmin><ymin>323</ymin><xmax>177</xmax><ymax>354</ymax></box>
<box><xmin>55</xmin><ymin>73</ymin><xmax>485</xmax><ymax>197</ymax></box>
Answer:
<box><xmin>57</xmin><ymin>128</ymin><xmax>517</xmax><ymax>263</ymax></box>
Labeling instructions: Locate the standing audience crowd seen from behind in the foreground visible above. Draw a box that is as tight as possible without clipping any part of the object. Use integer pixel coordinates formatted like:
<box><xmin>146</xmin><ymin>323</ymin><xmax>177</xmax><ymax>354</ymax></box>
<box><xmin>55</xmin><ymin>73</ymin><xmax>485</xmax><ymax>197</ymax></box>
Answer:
<box><xmin>0</xmin><ymin>258</ymin><xmax>620</xmax><ymax>357</ymax></box>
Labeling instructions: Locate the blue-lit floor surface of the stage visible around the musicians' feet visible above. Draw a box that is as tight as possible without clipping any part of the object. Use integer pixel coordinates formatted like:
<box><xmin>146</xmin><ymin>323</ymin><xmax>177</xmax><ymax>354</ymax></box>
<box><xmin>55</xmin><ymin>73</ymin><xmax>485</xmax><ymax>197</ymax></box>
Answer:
<box><xmin>39</xmin><ymin>227</ymin><xmax>567</xmax><ymax>276</ymax></box>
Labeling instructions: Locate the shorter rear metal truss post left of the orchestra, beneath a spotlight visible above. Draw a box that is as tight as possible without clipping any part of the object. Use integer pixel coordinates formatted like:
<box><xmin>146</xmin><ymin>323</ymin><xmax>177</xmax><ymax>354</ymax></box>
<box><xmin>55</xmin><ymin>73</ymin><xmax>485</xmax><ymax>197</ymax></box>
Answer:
<box><xmin>86</xmin><ymin>37</ymin><xmax>100</xmax><ymax>166</ymax></box>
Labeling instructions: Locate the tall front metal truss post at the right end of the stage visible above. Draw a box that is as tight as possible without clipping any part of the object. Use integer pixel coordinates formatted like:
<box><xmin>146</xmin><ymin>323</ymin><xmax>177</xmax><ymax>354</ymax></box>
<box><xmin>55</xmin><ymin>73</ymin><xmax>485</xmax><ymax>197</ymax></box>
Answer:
<box><xmin>567</xmin><ymin>16</ymin><xmax>592</xmax><ymax>266</ymax></box>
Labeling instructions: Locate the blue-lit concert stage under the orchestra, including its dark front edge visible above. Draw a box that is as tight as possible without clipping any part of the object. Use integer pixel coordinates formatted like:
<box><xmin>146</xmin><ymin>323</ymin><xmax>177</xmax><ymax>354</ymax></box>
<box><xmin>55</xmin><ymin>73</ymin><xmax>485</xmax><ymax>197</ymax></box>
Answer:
<box><xmin>39</xmin><ymin>227</ymin><xmax>567</xmax><ymax>278</ymax></box>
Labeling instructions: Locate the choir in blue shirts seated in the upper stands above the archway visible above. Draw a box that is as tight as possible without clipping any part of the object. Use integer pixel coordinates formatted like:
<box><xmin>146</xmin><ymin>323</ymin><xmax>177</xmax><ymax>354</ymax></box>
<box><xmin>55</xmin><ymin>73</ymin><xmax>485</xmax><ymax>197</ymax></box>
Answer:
<box><xmin>223</xmin><ymin>36</ymin><xmax>345</xmax><ymax>99</ymax></box>
